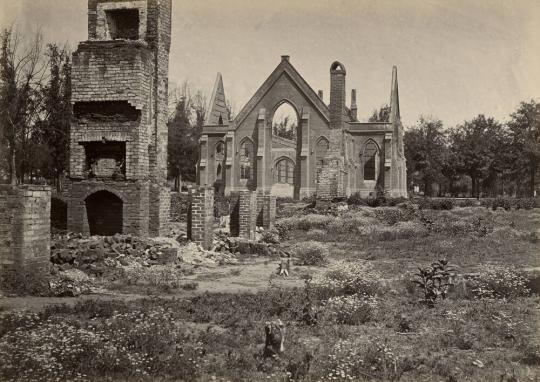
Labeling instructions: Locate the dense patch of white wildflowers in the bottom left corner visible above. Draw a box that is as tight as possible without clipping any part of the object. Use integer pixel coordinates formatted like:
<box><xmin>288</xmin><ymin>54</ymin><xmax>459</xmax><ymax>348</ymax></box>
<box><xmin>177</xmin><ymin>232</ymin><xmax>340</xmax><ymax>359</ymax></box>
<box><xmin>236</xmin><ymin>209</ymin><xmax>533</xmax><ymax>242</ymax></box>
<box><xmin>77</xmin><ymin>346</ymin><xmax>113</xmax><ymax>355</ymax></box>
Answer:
<box><xmin>0</xmin><ymin>307</ymin><xmax>203</xmax><ymax>381</ymax></box>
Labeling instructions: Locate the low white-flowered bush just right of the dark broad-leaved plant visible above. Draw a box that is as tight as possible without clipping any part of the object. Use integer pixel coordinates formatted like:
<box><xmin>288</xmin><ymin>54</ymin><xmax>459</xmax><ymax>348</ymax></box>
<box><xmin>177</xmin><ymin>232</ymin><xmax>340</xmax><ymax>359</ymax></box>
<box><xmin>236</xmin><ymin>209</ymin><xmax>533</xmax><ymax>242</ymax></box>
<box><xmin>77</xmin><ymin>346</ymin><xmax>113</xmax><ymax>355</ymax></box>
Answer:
<box><xmin>470</xmin><ymin>265</ymin><xmax>531</xmax><ymax>299</ymax></box>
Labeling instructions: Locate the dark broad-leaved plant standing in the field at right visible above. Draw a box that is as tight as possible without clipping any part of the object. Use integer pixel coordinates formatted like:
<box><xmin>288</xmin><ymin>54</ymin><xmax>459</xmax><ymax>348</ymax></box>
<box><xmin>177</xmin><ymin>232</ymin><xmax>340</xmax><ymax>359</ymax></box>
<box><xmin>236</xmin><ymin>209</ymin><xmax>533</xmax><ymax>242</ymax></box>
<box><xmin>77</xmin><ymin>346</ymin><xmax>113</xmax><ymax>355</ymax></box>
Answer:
<box><xmin>413</xmin><ymin>260</ymin><xmax>455</xmax><ymax>306</ymax></box>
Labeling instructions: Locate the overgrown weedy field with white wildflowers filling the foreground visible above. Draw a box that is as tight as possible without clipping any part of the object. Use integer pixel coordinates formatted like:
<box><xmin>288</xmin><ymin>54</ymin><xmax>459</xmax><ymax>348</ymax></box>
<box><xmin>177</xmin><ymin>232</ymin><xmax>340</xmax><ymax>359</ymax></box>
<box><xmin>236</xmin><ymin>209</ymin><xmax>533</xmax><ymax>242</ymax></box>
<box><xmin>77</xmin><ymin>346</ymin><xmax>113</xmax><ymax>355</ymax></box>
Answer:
<box><xmin>0</xmin><ymin>203</ymin><xmax>540</xmax><ymax>382</ymax></box>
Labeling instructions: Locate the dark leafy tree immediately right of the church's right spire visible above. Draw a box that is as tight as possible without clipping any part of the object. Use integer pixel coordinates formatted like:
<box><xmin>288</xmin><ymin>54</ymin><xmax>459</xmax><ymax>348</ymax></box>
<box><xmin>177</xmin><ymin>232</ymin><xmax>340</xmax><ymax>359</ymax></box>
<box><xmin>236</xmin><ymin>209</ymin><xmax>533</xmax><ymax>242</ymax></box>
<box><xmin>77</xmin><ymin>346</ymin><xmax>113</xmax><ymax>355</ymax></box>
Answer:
<box><xmin>403</xmin><ymin>117</ymin><xmax>447</xmax><ymax>196</ymax></box>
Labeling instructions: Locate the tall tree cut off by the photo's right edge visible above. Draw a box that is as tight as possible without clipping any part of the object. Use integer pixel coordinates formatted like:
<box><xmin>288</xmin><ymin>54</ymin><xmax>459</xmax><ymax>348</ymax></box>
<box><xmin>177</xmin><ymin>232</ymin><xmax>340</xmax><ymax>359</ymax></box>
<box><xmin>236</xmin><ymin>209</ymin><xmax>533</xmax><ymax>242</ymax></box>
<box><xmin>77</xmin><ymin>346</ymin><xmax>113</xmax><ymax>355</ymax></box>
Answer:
<box><xmin>508</xmin><ymin>100</ymin><xmax>540</xmax><ymax>196</ymax></box>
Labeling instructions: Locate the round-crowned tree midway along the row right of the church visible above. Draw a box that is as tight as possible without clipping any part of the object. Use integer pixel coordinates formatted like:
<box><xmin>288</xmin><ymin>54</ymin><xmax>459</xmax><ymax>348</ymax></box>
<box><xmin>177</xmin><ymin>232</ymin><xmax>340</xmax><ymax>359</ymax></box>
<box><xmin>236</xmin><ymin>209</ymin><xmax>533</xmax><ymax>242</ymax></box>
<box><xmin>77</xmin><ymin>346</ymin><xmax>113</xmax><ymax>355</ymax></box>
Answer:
<box><xmin>450</xmin><ymin>114</ymin><xmax>503</xmax><ymax>198</ymax></box>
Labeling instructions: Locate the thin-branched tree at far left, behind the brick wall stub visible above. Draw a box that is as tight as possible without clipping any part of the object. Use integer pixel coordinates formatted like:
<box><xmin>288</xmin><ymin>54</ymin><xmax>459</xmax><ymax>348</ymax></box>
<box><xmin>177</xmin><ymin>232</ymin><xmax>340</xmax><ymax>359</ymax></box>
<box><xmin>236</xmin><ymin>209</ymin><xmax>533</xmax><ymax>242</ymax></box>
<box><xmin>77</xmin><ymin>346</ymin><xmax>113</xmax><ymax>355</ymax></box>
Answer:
<box><xmin>0</xmin><ymin>28</ymin><xmax>47</xmax><ymax>185</ymax></box>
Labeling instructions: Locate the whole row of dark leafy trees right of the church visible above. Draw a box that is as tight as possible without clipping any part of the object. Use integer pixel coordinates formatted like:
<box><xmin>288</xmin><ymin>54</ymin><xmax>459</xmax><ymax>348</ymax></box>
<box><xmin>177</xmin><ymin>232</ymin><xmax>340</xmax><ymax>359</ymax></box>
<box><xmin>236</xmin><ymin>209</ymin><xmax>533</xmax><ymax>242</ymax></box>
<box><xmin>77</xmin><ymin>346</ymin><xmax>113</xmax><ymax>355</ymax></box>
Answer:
<box><xmin>404</xmin><ymin>100</ymin><xmax>540</xmax><ymax>197</ymax></box>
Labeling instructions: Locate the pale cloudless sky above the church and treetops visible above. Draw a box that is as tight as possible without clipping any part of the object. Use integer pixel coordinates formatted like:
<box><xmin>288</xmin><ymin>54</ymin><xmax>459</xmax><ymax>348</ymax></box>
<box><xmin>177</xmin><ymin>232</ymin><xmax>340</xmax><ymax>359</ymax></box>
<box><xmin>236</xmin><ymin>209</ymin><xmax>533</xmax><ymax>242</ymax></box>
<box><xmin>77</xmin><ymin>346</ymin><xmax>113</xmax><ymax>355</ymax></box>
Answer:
<box><xmin>0</xmin><ymin>0</ymin><xmax>540</xmax><ymax>127</ymax></box>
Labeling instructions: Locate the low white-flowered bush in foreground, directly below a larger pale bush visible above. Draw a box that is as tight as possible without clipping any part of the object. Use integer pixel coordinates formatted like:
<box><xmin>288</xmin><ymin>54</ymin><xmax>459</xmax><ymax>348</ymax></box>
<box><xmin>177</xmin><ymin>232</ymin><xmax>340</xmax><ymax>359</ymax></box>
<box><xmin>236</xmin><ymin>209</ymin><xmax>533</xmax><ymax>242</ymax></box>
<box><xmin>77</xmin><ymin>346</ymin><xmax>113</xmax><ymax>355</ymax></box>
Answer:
<box><xmin>325</xmin><ymin>294</ymin><xmax>379</xmax><ymax>325</ymax></box>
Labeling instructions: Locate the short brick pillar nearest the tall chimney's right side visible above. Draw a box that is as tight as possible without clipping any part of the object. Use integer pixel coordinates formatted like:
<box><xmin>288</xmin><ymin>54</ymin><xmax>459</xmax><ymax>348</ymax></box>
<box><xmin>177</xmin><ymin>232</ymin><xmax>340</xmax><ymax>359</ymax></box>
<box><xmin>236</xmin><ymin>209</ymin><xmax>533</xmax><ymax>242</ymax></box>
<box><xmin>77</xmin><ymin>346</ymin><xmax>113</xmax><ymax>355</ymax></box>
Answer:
<box><xmin>187</xmin><ymin>187</ymin><xmax>214</xmax><ymax>249</ymax></box>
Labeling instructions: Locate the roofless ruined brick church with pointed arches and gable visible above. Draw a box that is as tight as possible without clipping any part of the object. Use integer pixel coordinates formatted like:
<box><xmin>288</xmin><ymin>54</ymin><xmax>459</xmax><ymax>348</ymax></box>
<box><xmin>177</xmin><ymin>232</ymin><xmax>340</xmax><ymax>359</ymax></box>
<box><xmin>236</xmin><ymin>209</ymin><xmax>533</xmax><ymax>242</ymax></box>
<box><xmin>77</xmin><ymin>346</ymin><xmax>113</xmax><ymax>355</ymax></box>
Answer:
<box><xmin>198</xmin><ymin>56</ymin><xmax>407</xmax><ymax>199</ymax></box>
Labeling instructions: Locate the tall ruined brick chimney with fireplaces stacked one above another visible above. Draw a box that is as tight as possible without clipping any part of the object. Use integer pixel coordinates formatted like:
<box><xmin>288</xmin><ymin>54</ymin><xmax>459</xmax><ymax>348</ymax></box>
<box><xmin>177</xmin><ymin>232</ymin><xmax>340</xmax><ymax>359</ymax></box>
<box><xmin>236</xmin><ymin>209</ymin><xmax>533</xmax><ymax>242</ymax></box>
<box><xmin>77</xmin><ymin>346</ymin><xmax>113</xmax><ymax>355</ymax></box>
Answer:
<box><xmin>67</xmin><ymin>0</ymin><xmax>171</xmax><ymax>236</ymax></box>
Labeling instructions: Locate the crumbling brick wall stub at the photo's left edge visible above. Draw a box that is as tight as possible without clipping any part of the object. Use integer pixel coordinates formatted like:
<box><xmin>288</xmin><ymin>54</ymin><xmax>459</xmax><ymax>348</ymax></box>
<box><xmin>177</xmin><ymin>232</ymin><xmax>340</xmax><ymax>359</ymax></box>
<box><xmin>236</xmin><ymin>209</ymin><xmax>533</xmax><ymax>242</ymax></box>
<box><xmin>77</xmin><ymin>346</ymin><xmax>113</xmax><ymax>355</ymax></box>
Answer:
<box><xmin>0</xmin><ymin>185</ymin><xmax>51</xmax><ymax>285</ymax></box>
